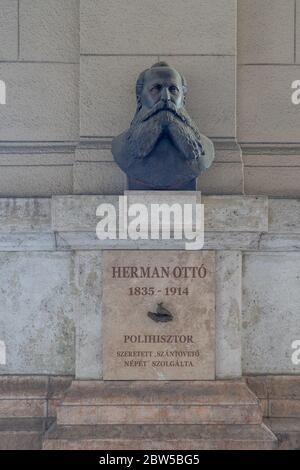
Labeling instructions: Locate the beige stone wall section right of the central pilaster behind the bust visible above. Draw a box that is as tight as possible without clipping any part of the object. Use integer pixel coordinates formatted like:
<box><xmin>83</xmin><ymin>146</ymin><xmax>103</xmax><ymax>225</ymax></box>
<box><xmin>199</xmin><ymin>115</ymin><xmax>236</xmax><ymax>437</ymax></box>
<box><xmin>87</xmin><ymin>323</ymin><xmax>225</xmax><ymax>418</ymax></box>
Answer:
<box><xmin>237</xmin><ymin>0</ymin><xmax>300</xmax><ymax>197</ymax></box>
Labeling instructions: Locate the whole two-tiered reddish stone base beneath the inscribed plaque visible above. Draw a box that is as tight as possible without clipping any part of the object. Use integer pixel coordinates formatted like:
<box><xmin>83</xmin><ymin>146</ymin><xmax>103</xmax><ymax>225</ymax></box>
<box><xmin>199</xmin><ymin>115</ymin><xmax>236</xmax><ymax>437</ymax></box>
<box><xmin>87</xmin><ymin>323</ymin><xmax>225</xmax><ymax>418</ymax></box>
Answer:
<box><xmin>43</xmin><ymin>380</ymin><xmax>277</xmax><ymax>450</ymax></box>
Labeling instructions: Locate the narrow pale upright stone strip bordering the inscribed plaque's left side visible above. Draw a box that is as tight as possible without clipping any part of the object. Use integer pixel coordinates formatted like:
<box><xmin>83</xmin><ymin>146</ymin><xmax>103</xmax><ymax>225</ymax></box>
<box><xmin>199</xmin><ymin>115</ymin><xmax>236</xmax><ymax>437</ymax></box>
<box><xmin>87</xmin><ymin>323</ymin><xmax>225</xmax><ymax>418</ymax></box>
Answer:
<box><xmin>74</xmin><ymin>251</ymin><xmax>102</xmax><ymax>379</ymax></box>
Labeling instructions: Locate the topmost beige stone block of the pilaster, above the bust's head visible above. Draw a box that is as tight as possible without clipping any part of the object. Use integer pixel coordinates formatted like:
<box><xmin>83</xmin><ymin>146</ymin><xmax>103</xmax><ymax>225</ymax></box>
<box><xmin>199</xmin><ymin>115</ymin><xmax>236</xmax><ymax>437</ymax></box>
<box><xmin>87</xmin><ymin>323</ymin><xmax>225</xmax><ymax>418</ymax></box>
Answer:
<box><xmin>81</xmin><ymin>0</ymin><xmax>236</xmax><ymax>55</ymax></box>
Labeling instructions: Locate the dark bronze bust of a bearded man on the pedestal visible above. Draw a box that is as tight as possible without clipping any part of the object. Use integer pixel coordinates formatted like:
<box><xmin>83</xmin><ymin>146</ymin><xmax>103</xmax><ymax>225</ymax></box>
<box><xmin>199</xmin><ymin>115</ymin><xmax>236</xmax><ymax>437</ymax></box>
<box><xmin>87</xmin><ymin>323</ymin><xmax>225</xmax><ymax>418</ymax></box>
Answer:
<box><xmin>112</xmin><ymin>62</ymin><xmax>214</xmax><ymax>191</ymax></box>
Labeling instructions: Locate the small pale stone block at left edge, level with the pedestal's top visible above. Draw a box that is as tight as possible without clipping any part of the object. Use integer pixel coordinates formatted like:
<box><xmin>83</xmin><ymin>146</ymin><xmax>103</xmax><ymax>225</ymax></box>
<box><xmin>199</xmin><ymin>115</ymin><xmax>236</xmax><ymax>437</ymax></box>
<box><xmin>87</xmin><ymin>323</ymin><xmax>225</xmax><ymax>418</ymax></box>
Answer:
<box><xmin>0</xmin><ymin>198</ymin><xmax>51</xmax><ymax>234</ymax></box>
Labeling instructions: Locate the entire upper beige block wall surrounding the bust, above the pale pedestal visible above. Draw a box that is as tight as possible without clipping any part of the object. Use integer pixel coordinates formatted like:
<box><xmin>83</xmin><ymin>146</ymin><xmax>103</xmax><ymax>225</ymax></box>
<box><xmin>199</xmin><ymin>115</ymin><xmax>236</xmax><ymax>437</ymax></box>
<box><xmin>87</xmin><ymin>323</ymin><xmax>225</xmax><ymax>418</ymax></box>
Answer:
<box><xmin>0</xmin><ymin>0</ymin><xmax>300</xmax><ymax>197</ymax></box>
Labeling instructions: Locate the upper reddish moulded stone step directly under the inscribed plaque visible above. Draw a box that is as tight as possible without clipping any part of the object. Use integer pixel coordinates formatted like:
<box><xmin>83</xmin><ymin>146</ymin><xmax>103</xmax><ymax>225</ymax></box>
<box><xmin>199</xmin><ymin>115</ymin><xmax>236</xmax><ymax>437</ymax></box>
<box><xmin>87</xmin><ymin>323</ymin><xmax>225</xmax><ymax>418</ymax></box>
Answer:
<box><xmin>57</xmin><ymin>380</ymin><xmax>262</xmax><ymax>425</ymax></box>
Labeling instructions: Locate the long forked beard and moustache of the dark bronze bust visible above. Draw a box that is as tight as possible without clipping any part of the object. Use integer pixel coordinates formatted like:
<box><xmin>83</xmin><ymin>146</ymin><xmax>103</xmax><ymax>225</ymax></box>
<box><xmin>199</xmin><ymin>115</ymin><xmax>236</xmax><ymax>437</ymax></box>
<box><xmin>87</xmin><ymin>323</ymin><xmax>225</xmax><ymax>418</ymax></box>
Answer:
<box><xmin>128</xmin><ymin>102</ymin><xmax>203</xmax><ymax>161</ymax></box>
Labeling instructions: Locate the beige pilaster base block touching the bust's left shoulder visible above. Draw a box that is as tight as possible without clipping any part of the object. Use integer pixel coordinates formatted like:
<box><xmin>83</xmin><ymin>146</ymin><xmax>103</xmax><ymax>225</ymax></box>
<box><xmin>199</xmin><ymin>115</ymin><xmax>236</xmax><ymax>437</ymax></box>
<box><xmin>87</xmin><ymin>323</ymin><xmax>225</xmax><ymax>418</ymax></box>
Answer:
<box><xmin>74</xmin><ymin>162</ymin><xmax>126</xmax><ymax>194</ymax></box>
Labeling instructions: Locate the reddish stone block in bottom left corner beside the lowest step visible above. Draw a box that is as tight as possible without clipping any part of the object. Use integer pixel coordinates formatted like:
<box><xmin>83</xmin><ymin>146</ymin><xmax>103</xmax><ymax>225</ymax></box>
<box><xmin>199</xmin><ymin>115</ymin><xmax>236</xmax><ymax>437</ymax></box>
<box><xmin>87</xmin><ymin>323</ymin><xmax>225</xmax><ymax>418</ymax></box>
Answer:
<box><xmin>0</xmin><ymin>418</ymin><xmax>47</xmax><ymax>450</ymax></box>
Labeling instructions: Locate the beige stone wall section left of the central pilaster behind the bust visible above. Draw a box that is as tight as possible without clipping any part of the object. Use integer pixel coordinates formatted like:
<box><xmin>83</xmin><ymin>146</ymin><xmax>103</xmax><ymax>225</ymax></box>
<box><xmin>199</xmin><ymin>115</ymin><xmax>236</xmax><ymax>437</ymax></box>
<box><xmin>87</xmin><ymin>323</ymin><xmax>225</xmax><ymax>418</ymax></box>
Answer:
<box><xmin>0</xmin><ymin>0</ymin><xmax>79</xmax><ymax>197</ymax></box>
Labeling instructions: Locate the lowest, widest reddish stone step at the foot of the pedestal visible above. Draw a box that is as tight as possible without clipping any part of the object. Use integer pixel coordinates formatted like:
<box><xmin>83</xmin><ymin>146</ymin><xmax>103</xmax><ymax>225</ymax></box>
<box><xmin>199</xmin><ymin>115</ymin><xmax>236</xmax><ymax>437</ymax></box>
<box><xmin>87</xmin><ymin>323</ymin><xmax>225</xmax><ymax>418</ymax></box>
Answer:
<box><xmin>43</xmin><ymin>424</ymin><xmax>277</xmax><ymax>450</ymax></box>
